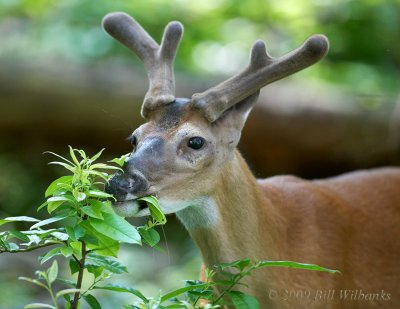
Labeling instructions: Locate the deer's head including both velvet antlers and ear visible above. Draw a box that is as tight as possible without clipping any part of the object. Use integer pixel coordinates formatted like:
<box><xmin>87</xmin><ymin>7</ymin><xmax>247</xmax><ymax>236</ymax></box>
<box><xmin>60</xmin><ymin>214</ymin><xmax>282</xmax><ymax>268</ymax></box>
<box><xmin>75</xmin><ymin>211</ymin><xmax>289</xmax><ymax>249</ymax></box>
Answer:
<box><xmin>103</xmin><ymin>13</ymin><xmax>328</xmax><ymax>216</ymax></box>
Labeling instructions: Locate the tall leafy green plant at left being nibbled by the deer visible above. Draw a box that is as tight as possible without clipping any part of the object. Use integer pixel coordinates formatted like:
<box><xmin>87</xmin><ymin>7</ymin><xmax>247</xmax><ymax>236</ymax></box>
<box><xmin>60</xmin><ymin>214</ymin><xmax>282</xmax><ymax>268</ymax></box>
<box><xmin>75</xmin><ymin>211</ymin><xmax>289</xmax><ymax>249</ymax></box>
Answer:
<box><xmin>0</xmin><ymin>147</ymin><xmax>166</xmax><ymax>309</ymax></box>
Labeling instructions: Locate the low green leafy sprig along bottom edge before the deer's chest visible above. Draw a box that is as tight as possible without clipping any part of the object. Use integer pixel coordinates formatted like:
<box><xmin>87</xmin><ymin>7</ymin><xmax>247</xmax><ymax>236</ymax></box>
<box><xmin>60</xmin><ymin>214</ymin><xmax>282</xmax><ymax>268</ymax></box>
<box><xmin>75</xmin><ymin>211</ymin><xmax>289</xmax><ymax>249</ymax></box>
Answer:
<box><xmin>126</xmin><ymin>259</ymin><xmax>338</xmax><ymax>309</ymax></box>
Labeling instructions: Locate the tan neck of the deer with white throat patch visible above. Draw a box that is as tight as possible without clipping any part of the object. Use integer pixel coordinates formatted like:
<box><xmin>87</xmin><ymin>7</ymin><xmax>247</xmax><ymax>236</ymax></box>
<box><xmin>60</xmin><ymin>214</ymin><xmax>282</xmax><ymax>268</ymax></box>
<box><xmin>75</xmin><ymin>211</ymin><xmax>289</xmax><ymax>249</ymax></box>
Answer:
<box><xmin>177</xmin><ymin>151</ymin><xmax>280</xmax><ymax>266</ymax></box>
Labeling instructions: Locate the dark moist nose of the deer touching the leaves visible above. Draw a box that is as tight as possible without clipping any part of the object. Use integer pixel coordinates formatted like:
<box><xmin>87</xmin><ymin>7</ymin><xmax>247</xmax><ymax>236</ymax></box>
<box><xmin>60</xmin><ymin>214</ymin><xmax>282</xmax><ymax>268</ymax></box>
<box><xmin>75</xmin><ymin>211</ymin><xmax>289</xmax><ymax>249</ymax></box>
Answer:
<box><xmin>105</xmin><ymin>172</ymin><xmax>149</xmax><ymax>202</ymax></box>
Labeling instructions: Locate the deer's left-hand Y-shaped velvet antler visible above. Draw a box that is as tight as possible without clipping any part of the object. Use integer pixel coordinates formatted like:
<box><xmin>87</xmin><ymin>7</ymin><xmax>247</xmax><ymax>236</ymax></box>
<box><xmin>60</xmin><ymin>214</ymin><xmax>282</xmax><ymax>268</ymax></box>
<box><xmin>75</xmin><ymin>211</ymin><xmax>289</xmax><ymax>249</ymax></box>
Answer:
<box><xmin>103</xmin><ymin>12</ymin><xmax>183</xmax><ymax>118</ymax></box>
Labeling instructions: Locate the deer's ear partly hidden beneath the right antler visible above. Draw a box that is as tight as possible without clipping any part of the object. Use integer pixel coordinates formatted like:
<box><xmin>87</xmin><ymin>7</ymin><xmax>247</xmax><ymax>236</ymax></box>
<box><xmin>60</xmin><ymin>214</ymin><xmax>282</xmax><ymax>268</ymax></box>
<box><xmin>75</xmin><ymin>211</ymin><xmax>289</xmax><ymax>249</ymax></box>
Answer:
<box><xmin>215</xmin><ymin>91</ymin><xmax>260</xmax><ymax>132</ymax></box>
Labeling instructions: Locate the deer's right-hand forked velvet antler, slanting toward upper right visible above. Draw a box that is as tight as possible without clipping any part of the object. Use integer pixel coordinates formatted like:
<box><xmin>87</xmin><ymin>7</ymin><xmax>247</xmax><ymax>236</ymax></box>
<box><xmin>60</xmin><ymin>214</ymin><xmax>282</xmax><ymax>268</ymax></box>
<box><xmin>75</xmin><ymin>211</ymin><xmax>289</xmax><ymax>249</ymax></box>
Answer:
<box><xmin>192</xmin><ymin>34</ymin><xmax>329</xmax><ymax>122</ymax></box>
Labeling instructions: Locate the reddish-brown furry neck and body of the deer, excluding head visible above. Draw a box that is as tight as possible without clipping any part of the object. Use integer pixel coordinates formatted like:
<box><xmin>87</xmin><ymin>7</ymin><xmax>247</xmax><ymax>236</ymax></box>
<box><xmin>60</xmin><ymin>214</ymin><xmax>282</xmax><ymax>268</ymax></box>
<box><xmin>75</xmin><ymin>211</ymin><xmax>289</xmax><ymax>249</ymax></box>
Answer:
<box><xmin>189</xmin><ymin>152</ymin><xmax>400</xmax><ymax>308</ymax></box>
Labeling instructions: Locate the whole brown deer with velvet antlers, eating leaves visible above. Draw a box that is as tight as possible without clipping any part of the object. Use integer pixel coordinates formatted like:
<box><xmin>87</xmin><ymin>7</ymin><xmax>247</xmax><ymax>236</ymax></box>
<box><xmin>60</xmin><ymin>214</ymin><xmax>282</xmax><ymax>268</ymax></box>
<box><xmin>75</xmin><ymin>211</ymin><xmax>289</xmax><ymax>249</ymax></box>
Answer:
<box><xmin>102</xmin><ymin>12</ymin><xmax>400</xmax><ymax>308</ymax></box>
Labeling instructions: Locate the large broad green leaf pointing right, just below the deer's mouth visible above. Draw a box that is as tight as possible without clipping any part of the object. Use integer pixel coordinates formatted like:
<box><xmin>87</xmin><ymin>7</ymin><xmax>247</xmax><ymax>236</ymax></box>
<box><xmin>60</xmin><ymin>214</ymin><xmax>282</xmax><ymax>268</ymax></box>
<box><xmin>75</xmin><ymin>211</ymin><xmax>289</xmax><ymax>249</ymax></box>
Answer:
<box><xmin>89</xmin><ymin>212</ymin><xmax>141</xmax><ymax>244</ymax></box>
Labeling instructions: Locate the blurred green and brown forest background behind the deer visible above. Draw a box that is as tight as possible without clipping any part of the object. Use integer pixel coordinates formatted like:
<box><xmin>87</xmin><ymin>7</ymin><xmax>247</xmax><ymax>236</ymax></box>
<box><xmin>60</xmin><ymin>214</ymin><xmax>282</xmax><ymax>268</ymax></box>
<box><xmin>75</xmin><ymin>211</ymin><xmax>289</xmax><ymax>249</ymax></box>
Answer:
<box><xmin>0</xmin><ymin>0</ymin><xmax>400</xmax><ymax>309</ymax></box>
